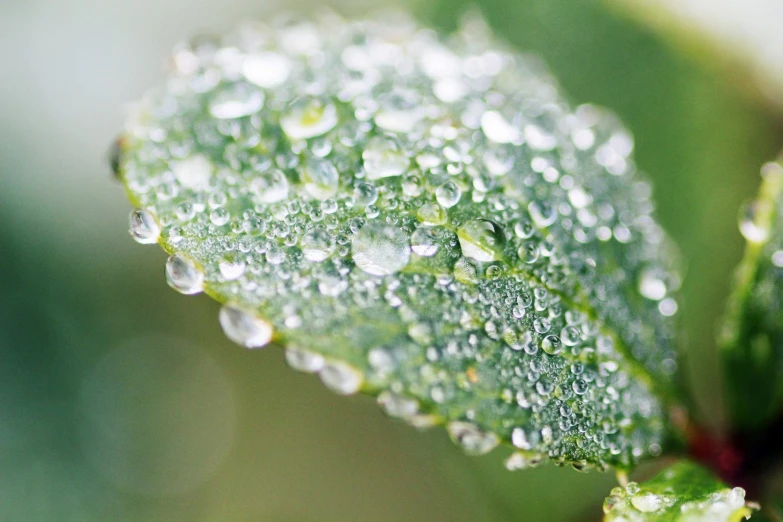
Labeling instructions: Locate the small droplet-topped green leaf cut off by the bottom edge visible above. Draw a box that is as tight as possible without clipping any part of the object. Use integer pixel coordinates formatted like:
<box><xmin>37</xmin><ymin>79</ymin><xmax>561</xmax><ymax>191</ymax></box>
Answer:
<box><xmin>604</xmin><ymin>461</ymin><xmax>752</xmax><ymax>522</ymax></box>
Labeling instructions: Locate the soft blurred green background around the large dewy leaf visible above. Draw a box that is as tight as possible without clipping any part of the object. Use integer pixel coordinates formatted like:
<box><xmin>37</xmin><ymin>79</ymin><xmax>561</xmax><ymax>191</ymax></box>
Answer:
<box><xmin>0</xmin><ymin>0</ymin><xmax>783</xmax><ymax>522</ymax></box>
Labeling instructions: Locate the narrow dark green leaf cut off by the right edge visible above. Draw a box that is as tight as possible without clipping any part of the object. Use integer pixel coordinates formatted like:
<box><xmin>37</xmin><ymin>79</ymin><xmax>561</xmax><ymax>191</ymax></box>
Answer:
<box><xmin>721</xmin><ymin>158</ymin><xmax>783</xmax><ymax>429</ymax></box>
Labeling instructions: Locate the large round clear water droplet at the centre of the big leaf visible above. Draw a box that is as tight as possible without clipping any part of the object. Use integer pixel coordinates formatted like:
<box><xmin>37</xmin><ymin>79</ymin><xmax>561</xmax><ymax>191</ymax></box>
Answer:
<box><xmin>351</xmin><ymin>223</ymin><xmax>411</xmax><ymax>276</ymax></box>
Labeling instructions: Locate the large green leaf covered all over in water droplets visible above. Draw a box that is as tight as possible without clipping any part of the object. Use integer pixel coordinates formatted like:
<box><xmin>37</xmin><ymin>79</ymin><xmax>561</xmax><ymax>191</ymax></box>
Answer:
<box><xmin>119</xmin><ymin>12</ymin><xmax>679</xmax><ymax>469</ymax></box>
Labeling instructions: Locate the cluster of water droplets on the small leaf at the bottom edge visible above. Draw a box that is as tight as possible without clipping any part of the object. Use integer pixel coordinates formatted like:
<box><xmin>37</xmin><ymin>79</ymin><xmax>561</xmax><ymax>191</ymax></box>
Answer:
<box><xmin>604</xmin><ymin>482</ymin><xmax>748</xmax><ymax>522</ymax></box>
